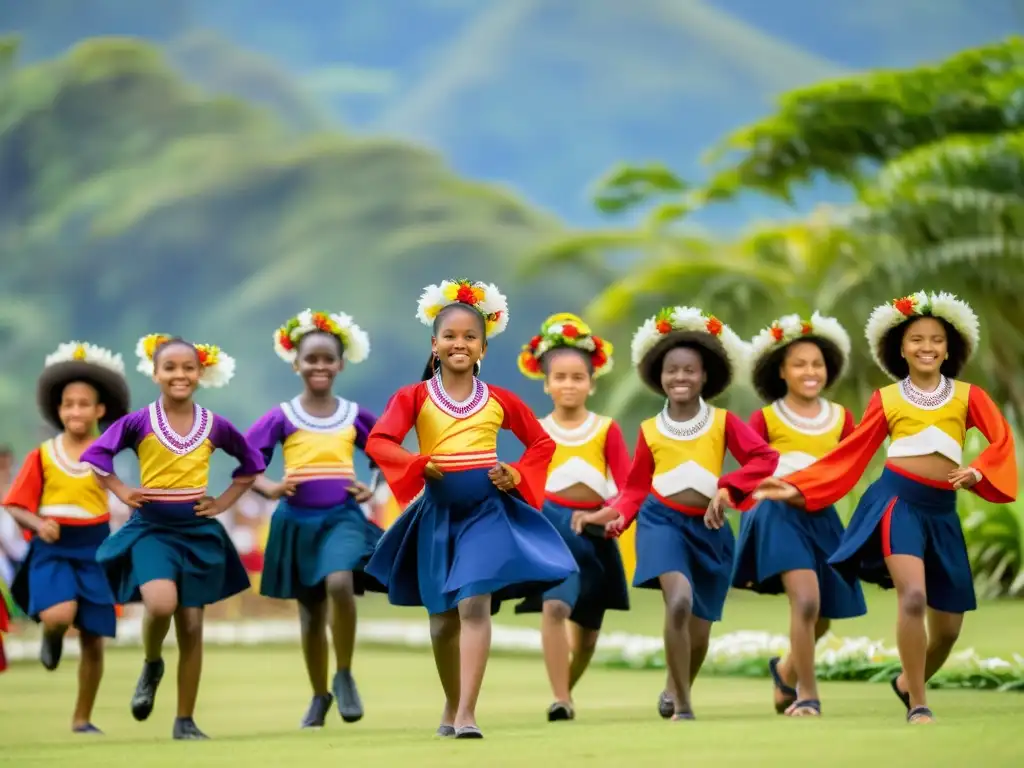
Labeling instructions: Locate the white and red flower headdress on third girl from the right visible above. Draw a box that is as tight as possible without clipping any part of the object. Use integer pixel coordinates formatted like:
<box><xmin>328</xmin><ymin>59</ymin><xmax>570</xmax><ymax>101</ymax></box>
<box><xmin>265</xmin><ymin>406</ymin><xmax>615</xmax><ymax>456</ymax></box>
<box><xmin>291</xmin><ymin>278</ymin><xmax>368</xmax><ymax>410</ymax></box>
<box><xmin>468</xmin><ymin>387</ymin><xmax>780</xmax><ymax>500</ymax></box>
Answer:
<box><xmin>632</xmin><ymin>306</ymin><xmax>748</xmax><ymax>399</ymax></box>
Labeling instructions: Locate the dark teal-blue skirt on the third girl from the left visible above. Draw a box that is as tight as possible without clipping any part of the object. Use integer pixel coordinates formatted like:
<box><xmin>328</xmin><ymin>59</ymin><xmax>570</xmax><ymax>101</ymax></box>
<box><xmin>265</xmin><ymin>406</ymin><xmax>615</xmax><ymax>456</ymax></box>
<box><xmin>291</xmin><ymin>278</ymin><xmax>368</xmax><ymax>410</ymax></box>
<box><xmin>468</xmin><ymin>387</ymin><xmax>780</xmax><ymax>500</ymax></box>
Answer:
<box><xmin>260</xmin><ymin>499</ymin><xmax>386</xmax><ymax>600</ymax></box>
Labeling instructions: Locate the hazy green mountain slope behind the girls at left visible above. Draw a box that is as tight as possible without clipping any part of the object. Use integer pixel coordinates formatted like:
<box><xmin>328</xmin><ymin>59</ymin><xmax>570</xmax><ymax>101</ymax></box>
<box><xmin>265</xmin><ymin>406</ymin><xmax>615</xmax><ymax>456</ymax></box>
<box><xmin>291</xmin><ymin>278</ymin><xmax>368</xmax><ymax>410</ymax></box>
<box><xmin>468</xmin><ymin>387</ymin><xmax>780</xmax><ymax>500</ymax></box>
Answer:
<box><xmin>0</xmin><ymin>39</ymin><xmax>592</xmax><ymax>456</ymax></box>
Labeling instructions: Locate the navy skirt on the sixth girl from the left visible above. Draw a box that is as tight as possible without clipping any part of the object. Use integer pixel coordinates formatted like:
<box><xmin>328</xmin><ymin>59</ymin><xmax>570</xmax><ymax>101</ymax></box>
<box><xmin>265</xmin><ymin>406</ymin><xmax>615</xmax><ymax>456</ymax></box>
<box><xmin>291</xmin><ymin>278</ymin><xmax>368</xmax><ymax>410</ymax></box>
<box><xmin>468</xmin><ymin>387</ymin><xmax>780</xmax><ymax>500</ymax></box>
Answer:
<box><xmin>633</xmin><ymin>496</ymin><xmax>736</xmax><ymax>622</ymax></box>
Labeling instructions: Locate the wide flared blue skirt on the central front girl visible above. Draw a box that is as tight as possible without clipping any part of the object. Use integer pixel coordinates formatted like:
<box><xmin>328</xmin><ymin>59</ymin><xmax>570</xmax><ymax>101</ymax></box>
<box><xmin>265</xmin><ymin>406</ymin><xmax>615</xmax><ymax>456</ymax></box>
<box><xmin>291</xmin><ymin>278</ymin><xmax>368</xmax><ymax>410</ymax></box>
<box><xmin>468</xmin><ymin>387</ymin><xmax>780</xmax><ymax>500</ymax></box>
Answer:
<box><xmin>366</xmin><ymin>469</ymin><xmax>579</xmax><ymax>614</ymax></box>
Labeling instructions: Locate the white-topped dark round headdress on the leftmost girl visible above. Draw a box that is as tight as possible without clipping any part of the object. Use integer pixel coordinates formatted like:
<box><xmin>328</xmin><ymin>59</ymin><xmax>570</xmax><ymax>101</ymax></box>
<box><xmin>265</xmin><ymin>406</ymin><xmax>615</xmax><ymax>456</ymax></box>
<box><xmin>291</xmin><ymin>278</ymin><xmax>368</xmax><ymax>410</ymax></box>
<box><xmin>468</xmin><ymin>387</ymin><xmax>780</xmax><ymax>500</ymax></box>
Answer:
<box><xmin>36</xmin><ymin>341</ymin><xmax>131</xmax><ymax>430</ymax></box>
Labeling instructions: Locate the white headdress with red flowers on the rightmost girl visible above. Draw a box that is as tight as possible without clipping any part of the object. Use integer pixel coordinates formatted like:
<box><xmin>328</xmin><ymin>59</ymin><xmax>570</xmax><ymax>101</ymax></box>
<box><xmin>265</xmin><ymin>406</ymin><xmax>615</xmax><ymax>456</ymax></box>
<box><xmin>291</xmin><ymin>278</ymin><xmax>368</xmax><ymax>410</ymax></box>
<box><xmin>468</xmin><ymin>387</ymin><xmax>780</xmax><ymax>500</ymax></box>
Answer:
<box><xmin>864</xmin><ymin>291</ymin><xmax>981</xmax><ymax>381</ymax></box>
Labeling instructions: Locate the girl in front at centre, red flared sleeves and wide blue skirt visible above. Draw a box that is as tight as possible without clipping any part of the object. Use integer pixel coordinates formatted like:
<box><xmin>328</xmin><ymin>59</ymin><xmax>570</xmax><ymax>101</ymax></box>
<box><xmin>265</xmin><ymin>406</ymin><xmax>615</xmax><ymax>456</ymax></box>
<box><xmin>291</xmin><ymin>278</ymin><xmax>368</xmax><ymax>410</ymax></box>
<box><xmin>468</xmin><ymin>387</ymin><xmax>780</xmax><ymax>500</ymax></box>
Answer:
<box><xmin>367</xmin><ymin>281</ymin><xmax>578</xmax><ymax>738</ymax></box>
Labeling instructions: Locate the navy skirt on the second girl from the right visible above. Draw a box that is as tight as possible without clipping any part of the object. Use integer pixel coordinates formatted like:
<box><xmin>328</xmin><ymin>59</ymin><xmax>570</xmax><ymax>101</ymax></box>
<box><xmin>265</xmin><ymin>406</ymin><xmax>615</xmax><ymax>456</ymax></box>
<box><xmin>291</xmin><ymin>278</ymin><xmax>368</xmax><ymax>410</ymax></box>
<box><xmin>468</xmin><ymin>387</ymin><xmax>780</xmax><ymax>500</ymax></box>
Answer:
<box><xmin>732</xmin><ymin>501</ymin><xmax>867</xmax><ymax>618</ymax></box>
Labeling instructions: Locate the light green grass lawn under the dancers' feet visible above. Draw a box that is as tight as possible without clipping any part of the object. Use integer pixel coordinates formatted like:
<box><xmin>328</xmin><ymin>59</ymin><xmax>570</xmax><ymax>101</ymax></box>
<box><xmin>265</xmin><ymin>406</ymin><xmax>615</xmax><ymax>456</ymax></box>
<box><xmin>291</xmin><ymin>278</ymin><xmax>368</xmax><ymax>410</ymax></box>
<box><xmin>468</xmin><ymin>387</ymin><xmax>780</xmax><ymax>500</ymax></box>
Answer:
<box><xmin>6</xmin><ymin>590</ymin><xmax>1024</xmax><ymax>768</ymax></box>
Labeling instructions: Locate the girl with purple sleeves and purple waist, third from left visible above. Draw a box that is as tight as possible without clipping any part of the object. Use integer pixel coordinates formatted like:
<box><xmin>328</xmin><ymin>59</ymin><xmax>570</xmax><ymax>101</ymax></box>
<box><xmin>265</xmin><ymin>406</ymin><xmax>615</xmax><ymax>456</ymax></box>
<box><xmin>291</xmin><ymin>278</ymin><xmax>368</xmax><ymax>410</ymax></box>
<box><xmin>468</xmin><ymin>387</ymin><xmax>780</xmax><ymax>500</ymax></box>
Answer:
<box><xmin>246</xmin><ymin>309</ymin><xmax>383</xmax><ymax>728</ymax></box>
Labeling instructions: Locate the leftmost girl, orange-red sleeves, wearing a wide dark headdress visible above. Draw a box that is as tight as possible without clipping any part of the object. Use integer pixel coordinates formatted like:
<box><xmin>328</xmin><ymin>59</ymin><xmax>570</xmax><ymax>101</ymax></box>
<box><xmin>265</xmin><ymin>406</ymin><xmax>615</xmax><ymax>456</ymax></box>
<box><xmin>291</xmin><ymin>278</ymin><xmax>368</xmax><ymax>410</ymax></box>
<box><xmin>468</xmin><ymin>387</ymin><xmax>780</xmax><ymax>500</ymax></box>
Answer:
<box><xmin>3</xmin><ymin>341</ymin><xmax>129</xmax><ymax>734</ymax></box>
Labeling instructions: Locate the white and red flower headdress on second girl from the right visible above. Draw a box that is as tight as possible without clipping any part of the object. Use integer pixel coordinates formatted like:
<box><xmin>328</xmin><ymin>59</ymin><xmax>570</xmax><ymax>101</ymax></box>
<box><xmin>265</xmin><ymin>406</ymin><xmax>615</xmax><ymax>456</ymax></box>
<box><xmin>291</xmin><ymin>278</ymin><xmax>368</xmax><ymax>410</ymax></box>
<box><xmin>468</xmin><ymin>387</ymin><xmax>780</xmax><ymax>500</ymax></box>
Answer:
<box><xmin>750</xmin><ymin>312</ymin><xmax>852</xmax><ymax>401</ymax></box>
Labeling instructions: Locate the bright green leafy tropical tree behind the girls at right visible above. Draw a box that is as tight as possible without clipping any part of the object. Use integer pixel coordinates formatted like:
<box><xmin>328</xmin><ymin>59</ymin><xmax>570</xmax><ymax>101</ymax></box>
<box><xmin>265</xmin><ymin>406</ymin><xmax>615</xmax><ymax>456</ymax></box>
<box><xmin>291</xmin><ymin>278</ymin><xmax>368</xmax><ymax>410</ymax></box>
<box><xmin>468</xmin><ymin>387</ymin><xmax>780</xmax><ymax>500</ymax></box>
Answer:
<box><xmin>527</xmin><ymin>38</ymin><xmax>1024</xmax><ymax>434</ymax></box>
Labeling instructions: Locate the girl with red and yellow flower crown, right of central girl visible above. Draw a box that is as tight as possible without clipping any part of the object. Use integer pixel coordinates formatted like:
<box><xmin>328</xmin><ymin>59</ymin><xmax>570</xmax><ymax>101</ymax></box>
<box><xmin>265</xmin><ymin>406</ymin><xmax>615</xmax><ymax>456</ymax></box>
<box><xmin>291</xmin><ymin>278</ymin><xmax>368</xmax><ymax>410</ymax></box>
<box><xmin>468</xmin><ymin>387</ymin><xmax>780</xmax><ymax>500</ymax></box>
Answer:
<box><xmin>516</xmin><ymin>312</ymin><xmax>630</xmax><ymax>722</ymax></box>
